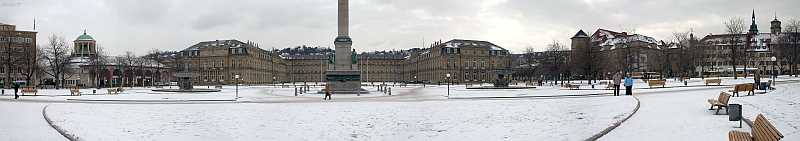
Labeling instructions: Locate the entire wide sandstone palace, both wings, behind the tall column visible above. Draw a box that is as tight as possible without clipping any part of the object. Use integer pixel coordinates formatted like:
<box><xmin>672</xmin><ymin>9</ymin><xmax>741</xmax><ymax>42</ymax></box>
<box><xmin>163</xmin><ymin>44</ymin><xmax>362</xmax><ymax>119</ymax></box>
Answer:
<box><xmin>181</xmin><ymin>39</ymin><xmax>511</xmax><ymax>85</ymax></box>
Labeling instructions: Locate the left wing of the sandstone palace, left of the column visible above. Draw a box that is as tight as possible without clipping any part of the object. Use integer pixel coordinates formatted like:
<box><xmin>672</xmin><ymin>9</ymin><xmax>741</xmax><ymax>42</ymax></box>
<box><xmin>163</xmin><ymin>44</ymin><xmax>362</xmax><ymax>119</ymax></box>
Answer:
<box><xmin>179</xmin><ymin>40</ymin><xmax>290</xmax><ymax>85</ymax></box>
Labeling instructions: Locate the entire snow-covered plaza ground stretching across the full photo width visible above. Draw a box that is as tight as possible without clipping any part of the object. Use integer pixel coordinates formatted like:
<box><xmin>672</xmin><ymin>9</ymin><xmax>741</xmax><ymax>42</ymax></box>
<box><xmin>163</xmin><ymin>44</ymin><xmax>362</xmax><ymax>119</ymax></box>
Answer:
<box><xmin>0</xmin><ymin>76</ymin><xmax>800</xmax><ymax>141</ymax></box>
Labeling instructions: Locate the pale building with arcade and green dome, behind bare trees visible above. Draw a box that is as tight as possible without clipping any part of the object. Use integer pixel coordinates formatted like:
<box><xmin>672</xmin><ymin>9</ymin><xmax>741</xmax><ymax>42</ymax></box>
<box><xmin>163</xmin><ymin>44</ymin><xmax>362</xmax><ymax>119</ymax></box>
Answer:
<box><xmin>64</xmin><ymin>31</ymin><xmax>172</xmax><ymax>88</ymax></box>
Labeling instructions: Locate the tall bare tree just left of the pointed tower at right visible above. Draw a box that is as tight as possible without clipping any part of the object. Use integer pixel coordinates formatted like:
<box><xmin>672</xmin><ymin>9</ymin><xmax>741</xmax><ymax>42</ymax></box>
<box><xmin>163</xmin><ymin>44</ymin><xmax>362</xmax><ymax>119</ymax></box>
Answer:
<box><xmin>724</xmin><ymin>17</ymin><xmax>745</xmax><ymax>79</ymax></box>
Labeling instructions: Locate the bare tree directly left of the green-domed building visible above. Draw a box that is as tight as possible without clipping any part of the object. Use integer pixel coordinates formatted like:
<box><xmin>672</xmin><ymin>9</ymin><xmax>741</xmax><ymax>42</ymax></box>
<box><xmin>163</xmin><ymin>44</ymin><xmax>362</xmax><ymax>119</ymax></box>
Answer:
<box><xmin>41</xmin><ymin>35</ymin><xmax>70</xmax><ymax>88</ymax></box>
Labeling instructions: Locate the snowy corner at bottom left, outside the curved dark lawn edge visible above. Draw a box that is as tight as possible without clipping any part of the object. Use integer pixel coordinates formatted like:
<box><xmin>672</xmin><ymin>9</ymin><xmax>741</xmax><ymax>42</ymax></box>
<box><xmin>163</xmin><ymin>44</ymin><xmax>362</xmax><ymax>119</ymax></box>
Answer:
<box><xmin>0</xmin><ymin>100</ymin><xmax>67</xmax><ymax>141</ymax></box>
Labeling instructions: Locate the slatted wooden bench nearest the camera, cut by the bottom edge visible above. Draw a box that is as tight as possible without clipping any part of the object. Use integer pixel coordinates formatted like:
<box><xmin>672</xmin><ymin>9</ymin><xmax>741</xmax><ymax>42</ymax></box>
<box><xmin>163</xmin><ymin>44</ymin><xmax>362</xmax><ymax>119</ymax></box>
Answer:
<box><xmin>728</xmin><ymin>114</ymin><xmax>783</xmax><ymax>141</ymax></box>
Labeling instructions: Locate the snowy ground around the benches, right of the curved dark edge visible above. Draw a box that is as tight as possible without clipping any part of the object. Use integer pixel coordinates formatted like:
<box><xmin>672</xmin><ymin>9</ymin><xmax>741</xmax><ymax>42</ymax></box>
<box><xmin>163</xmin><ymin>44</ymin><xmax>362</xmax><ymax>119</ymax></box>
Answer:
<box><xmin>601</xmin><ymin>77</ymin><xmax>800</xmax><ymax>141</ymax></box>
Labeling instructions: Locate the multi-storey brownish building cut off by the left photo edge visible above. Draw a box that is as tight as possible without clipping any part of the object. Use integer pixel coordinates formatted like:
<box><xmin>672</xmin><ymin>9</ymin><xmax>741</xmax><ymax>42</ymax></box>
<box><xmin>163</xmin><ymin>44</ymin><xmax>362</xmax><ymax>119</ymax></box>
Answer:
<box><xmin>0</xmin><ymin>23</ymin><xmax>39</xmax><ymax>88</ymax></box>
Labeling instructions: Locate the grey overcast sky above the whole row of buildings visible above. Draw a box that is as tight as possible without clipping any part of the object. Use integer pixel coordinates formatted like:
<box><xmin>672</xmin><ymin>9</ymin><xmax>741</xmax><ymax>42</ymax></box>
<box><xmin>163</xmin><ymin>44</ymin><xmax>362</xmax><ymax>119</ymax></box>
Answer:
<box><xmin>0</xmin><ymin>0</ymin><xmax>800</xmax><ymax>55</ymax></box>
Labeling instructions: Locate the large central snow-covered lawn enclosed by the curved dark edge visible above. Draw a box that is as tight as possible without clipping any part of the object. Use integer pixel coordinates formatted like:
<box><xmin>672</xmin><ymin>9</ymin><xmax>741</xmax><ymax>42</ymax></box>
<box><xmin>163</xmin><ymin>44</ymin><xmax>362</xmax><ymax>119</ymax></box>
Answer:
<box><xmin>46</xmin><ymin>97</ymin><xmax>636</xmax><ymax>140</ymax></box>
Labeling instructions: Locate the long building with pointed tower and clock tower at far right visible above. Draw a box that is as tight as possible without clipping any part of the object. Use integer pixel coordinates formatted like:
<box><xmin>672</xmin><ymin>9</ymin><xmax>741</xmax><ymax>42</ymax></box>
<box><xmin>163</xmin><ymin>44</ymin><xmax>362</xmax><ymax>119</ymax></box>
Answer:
<box><xmin>696</xmin><ymin>12</ymin><xmax>800</xmax><ymax>76</ymax></box>
